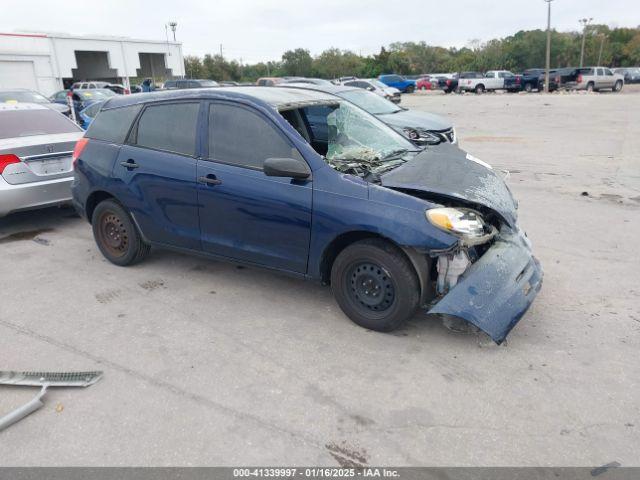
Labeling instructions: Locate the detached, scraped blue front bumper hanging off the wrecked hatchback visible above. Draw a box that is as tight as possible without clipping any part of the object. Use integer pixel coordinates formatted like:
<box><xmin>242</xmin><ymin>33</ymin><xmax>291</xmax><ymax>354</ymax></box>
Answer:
<box><xmin>428</xmin><ymin>229</ymin><xmax>543</xmax><ymax>344</ymax></box>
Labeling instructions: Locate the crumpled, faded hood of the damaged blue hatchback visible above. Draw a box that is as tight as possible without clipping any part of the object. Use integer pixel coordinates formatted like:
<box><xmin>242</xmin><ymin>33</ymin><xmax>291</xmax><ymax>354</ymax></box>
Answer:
<box><xmin>380</xmin><ymin>143</ymin><xmax>517</xmax><ymax>228</ymax></box>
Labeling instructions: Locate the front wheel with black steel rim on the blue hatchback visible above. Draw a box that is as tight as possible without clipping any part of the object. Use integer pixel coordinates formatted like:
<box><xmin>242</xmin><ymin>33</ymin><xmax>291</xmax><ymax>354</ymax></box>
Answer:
<box><xmin>331</xmin><ymin>239</ymin><xmax>420</xmax><ymax>332</ymax></box>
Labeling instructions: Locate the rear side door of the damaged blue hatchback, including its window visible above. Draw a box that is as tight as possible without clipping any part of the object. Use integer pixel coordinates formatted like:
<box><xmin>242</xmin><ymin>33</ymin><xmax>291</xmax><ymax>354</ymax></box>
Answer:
<box><xmin>113</xmin><ymin>101</ymin><xmax>200</xmax><ymax>250</ymax></box>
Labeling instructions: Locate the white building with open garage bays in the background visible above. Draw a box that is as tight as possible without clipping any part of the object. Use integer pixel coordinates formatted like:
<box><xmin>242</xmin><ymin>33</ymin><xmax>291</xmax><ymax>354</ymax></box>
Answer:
<box><xmin>0</xmin><ymin>33</ymin><xmax>184</xmax><ymax>95</ymax></box>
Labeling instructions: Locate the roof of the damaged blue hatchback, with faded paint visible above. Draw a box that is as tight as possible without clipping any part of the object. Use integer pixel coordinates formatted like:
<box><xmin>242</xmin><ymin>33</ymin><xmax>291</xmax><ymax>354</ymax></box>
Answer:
<box><xmin>105</xmin><ymin>86</ymin><xmax>337</xmax><ymax>109</ymax></box>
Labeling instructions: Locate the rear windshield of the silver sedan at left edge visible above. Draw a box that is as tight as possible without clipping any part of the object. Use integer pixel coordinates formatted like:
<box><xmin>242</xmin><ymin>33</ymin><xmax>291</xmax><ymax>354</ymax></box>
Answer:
<box><xmin>0</xmin><ymin>108</ymin><xmax>82</xmax><ymax>138</ymax></box>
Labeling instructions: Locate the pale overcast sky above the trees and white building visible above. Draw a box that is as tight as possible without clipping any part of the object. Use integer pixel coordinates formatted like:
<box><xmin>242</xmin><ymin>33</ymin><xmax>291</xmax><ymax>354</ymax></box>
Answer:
<box><xmin>5</xmin><ymin>0</ymin><xmax>640</xmax><ymax>63</ymax></box>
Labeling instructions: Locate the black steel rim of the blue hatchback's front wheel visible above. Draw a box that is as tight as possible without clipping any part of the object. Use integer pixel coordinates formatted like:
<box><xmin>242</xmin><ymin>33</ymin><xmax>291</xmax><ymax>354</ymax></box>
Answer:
<box><xmin>347</xmin><ymin>262</ymin><xmax>396</xmax><ymax>315</ymax></box>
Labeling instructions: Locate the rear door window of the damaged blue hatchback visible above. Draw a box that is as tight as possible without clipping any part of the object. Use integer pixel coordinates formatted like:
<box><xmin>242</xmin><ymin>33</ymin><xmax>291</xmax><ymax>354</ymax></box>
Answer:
<box><xmin>136</xmin><ymin>102</ymin><xmax>200</xmax><ymax>156</ymax></box>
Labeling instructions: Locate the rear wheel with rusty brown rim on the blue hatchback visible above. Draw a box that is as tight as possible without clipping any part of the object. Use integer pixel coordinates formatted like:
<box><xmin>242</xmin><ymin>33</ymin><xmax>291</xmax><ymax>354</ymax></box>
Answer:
<box><xmin>91</xmin><ymin>200</ymin><xmax>151</xmax><ymax>267</ymax></box>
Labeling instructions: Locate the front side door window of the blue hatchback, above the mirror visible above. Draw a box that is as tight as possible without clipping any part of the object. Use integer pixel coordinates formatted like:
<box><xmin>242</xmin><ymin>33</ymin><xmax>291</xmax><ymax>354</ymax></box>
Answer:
<box><xmin>209</xmin><ymin>103</ymin><xmax>301</xmax><ymax>170</ymax></box>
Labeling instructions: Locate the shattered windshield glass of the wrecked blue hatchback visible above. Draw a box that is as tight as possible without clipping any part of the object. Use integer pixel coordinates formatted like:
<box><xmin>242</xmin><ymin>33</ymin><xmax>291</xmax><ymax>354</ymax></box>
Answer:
<box><xmin>307</xmin><ymin>101</ymin><xmax>417</xmax><ymax>178</ymax></box>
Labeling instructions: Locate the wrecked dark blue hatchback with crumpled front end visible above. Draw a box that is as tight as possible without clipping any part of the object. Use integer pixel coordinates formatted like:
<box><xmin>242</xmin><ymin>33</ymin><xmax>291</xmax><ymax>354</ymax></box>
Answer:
<box><xmin>72</xmin><ymin>87</ymin><xmax>542</xmax><ymax>343</ymax></box>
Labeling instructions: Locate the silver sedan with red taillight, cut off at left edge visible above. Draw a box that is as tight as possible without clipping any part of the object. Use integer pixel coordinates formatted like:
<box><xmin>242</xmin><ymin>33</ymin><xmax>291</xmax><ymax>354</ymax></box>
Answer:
<box><xmin>0</xmin><ymin>103</ymin><xmax>82</xmax><ymax>217</ymax></box>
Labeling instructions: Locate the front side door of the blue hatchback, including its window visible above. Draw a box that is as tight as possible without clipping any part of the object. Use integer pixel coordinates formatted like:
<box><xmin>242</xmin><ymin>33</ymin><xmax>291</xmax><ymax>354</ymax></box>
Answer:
<box><xmin>197</xmin><ymin>102</ymin><xmax>312</xmax><ymax>273</ymax></box>
